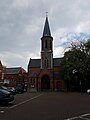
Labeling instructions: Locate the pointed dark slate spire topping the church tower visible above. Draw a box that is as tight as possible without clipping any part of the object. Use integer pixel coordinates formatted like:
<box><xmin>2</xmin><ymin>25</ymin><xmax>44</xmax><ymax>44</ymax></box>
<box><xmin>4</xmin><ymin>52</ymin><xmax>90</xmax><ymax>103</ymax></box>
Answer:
<box><xmin>42</xmin><ymin>16</ymin><xmax>51</xmax><ymax>37</ymax></box>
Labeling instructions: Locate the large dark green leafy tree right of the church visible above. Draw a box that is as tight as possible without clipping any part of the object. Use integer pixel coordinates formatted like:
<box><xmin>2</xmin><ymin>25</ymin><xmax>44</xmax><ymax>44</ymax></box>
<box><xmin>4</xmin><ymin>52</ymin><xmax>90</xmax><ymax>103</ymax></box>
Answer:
<box><xmin>60</xmin><ymin>40</ymin><xmax>90</xmax><ymax>91</ymax></box>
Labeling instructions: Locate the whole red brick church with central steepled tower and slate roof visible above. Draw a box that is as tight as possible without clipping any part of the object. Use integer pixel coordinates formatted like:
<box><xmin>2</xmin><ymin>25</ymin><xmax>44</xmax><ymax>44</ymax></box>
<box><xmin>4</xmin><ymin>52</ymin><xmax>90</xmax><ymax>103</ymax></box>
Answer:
<box><xmin>28</xmin><ymin>16</ymin><xmax>65</xmax><ymax>91</ymax></box>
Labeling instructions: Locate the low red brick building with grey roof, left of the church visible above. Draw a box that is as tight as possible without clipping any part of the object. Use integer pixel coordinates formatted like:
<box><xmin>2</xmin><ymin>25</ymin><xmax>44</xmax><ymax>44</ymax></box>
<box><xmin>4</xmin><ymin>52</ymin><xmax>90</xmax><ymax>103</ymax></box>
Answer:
<box><xmin>4</xmin><ymin>67</ymin><xmax>26</xmax><ymax>86</ymax></box>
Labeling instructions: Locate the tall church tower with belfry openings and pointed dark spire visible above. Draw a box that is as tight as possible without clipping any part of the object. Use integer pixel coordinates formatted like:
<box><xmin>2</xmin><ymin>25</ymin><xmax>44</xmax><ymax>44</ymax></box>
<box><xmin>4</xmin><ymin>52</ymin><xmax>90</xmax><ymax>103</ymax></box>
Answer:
<box><xmin>41</xmin><ymin>15</ymin><xmax>53</xmax><ymax>69</ymax></box>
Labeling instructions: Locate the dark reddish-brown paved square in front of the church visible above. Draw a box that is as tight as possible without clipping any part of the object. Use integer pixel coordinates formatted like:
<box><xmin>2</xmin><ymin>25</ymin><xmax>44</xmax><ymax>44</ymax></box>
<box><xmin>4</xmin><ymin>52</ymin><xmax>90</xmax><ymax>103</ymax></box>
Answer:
<box><xmin>0</xmin><ymin>92</ymin><xmax>90</xmax><ymax>120</ymax></box>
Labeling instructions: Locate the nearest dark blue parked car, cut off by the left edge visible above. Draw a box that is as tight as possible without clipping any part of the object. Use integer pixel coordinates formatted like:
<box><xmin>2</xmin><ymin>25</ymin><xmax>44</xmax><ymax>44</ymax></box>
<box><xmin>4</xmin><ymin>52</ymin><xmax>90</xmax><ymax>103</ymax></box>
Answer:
<box><xmin>0</xmin><ymin>89</ymin><xmax>14</xmax><ymax>104</ymax></box>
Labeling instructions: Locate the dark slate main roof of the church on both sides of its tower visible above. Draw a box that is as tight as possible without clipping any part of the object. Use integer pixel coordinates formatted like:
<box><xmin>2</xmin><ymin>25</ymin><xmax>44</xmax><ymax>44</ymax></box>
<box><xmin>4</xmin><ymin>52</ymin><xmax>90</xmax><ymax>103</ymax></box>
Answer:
<box><xmin>28</xmin><ymin>58</ymin><xmax>61</xmax><ymax>67</ymax></box>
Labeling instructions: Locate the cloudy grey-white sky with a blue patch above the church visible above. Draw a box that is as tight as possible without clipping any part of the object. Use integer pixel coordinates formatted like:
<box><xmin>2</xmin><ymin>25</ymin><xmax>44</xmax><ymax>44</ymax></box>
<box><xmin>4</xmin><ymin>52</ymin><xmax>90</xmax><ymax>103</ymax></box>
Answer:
<box><xmin>0</xmin><ymin>0</ymin><xmax>90</xmax><ymax>69</ymax></box>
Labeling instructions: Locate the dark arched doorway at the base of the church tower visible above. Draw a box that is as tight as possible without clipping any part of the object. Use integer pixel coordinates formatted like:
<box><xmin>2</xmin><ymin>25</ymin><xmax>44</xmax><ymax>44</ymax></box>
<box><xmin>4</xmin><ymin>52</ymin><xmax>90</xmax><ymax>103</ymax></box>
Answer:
<box><xmin>41</xmin><ymin>75</ymin><xmax>50</xmax><ymax>91</ymax></box>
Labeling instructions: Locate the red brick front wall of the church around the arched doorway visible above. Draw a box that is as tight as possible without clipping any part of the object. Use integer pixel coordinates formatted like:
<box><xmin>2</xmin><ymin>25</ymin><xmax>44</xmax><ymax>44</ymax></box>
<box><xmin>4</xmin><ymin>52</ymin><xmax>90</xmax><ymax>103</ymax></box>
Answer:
<box><xmin>28</xmin><ymin>66</ymin><xmax>64</xmax><ymax>90</ymax></box>
